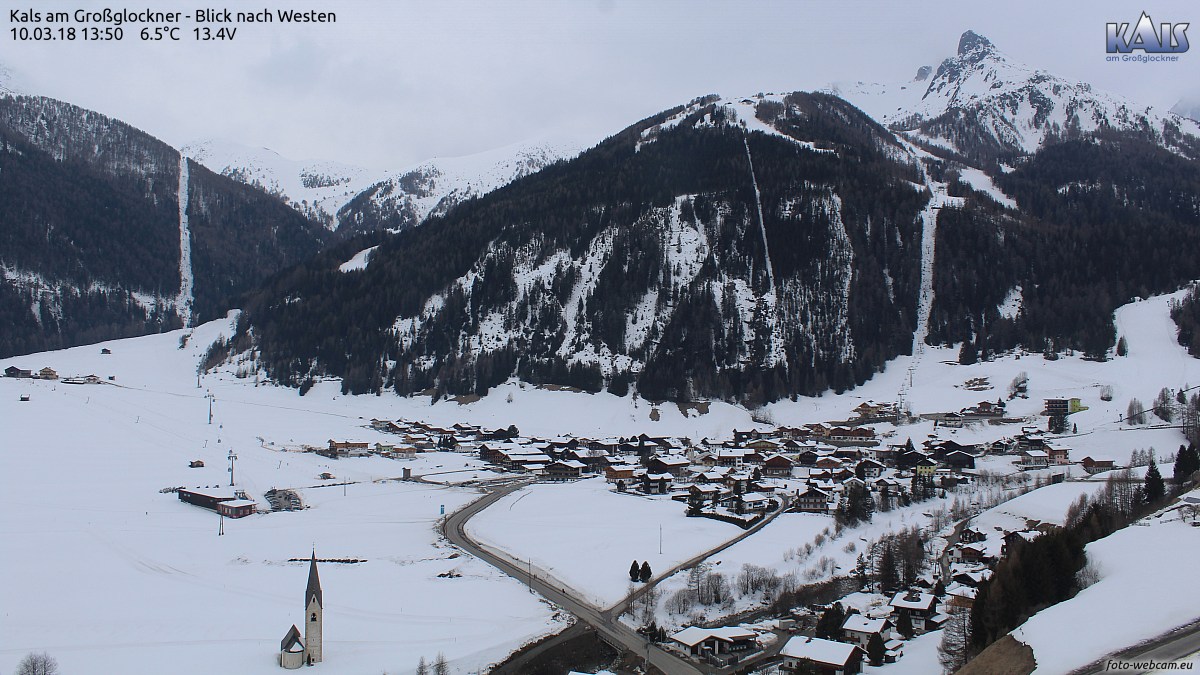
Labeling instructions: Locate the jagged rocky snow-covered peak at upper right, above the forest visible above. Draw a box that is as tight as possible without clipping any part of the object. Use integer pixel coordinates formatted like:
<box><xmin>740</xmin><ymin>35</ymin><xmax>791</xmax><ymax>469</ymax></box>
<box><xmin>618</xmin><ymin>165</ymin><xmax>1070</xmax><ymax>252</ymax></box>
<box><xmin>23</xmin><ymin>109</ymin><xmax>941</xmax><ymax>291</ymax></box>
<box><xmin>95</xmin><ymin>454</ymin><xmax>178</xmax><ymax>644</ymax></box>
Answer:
<box><xmin>828</xmin><ymin>31</ymin><xmax>1200</xmax><ymax>160</ymax></box>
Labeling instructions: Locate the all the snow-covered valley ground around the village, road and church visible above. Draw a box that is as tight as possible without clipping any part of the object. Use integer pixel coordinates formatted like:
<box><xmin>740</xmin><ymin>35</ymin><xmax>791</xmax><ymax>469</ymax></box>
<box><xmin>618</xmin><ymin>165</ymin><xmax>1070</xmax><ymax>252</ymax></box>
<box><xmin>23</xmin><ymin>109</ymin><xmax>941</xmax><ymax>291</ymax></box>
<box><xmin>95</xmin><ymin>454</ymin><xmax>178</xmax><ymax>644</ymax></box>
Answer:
<box><xmin>0</xmin><ymin>285</ymin><xmax>1200</xmax><ymax>673</ymax></box>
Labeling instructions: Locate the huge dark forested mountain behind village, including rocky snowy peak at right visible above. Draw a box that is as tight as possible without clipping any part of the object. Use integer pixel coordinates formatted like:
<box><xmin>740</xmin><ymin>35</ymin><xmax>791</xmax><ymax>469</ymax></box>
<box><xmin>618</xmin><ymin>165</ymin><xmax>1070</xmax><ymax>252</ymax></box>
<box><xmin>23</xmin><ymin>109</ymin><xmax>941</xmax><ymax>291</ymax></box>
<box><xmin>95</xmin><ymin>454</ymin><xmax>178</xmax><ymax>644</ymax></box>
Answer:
<box><xmin>226</xmin><ymin>31</ymin><xmax>1200</xmax><ymax>405</ymax></box>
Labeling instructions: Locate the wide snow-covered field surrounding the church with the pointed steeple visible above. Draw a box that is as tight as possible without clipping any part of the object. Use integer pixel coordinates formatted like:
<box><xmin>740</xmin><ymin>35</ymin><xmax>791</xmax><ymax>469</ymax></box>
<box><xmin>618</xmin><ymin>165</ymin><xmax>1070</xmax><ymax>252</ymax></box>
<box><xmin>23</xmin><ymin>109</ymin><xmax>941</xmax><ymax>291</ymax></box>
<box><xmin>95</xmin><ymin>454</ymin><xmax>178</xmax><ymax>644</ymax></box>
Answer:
<box><xmin>0</xmin><ymin>314</ymin><xmax>563</xmax><ymax>675</ymax></box>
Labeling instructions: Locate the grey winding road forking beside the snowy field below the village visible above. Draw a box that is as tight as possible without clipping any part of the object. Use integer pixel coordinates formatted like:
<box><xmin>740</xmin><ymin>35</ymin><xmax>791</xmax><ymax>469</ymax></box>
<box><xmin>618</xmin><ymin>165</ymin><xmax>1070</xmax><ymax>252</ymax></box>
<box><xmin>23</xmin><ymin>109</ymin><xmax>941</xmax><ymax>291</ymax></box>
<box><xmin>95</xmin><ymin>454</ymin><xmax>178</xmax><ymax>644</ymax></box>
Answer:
<box><xmin>442</xmin><ymin>483</ymin><xmax>786</xmax><ymax>675</ymax></box>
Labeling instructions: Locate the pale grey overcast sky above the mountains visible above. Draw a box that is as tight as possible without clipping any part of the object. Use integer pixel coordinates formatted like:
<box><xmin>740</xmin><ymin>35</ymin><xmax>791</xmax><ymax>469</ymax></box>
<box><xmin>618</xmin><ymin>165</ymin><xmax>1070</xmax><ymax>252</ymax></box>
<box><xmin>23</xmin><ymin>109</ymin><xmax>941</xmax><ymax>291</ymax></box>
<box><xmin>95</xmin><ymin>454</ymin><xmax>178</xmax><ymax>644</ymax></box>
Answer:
<box><xmin>0</xmin><ymin>0</ymin><xmax>1200</xmax><ymax>169</ymax></box>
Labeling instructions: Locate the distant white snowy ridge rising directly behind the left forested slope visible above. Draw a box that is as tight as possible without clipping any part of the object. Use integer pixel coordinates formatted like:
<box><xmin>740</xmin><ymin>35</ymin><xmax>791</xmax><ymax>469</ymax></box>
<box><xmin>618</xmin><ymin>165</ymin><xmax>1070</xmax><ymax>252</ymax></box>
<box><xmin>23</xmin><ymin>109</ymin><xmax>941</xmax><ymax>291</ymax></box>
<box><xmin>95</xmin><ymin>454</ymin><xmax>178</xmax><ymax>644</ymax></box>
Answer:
<box><xmin>180</xmin><ymin>138</ymin><xmax>369</xmax><ymax>229</ymax></box>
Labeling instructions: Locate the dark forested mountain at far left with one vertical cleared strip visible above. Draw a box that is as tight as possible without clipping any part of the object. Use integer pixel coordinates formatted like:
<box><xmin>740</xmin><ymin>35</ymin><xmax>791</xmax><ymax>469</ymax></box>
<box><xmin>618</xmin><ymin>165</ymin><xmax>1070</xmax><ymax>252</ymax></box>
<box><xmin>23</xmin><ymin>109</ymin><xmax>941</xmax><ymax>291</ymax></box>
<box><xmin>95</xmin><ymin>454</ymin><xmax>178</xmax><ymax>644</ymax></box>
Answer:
<box><xmin>0</xmin><ymin>95</ymin><xmax>326</xmax><ymax>354</ymax></box>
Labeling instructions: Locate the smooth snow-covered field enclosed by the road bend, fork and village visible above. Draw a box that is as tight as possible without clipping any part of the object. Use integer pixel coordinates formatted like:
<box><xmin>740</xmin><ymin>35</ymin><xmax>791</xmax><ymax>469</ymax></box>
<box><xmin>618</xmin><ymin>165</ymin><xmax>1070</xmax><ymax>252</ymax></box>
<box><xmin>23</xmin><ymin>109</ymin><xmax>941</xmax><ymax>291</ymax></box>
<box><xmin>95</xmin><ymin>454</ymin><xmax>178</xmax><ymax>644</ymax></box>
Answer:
<box><xmin>467</xmin><ymin>478</ymin><xmax>742</xmax><ymax>608</ymax></box>
